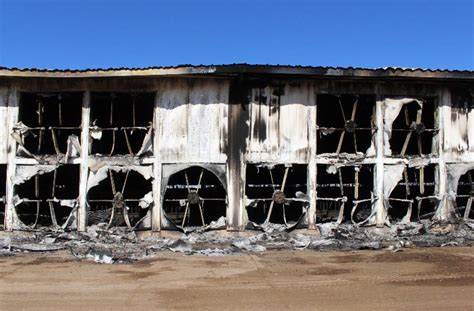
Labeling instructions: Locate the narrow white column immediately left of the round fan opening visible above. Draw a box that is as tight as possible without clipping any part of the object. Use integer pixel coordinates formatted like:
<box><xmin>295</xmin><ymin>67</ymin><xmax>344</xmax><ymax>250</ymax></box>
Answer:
<box><xmin>151</xmin><ymin>92</ymin><xmax>163</xmax><ymax>231</ymax></box>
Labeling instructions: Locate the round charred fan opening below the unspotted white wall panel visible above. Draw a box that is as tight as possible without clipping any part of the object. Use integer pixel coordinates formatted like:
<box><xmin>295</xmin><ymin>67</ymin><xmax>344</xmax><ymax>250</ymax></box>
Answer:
<box><xmin>163</xmin><ymin>166</ymin><xmax>227</xmax><ymax>227</ymax></box>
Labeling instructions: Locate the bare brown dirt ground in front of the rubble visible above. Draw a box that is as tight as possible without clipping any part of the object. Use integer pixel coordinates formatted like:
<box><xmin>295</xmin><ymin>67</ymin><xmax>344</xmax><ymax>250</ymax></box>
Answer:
<box><xmin>0</xmin><ymin>247</ymin><xmax>474</xmax><ymax>310</ymax></box>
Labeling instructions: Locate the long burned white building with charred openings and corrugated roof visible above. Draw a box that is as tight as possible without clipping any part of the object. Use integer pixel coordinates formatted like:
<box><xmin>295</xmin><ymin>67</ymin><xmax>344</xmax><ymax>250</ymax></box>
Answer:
<box><xmin>0</xmin><ymin>64</ymin><xmax>474</xmax><ymax>231</ymax></box>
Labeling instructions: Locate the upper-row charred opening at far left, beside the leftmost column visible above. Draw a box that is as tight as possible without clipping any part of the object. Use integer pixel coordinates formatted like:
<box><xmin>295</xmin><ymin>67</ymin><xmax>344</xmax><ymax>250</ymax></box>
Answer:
<box><xmin>15</xmin><ymin>92</ymin><xmax>82</xmax><ymax>155</ymax></box>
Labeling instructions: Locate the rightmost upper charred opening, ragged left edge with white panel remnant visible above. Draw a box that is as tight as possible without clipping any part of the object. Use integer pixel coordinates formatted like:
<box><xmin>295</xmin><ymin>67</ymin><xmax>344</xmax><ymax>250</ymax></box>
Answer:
<box><xmin>390</xmin><ymin>98</ymin><xmax>437</xmax><ymax>156</ymax></box>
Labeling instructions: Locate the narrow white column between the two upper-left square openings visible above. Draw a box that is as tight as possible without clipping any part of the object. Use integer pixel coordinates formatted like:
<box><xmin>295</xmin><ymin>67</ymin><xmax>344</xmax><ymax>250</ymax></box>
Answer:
<box><xmin>77</xmin><ymin>91</ymin><xmax>90</xmax><ymax>231</ymax></box>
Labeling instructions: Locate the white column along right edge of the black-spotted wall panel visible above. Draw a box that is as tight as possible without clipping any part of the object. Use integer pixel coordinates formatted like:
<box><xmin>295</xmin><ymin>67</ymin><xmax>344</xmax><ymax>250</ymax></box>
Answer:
<box><xmin>307</xmin><ymin>87</ymin><xmax>318</xmax><ymax>230</ymax></box>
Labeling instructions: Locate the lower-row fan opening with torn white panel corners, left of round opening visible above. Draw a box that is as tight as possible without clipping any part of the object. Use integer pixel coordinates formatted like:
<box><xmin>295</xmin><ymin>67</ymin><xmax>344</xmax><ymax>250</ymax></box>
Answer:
<box><xmin>87</xmin><ymin>166</ymin><xmax>153</xmax><ymax>229</ymax></box>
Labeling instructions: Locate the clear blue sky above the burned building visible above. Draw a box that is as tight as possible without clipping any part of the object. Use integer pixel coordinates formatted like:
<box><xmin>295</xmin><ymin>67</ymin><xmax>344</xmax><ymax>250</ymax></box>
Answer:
<box><xmin>0</xmin><ymin>0</ymin><xmax>474</xmax><ymax>70</ymax></box>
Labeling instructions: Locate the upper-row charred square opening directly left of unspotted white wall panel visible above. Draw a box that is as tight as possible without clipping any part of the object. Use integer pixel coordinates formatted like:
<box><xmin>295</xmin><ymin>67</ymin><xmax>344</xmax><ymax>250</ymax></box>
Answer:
<box><xmin>90</xmin><ymin>93</ymin><xmax>155</xmax><ymax>156</ymax></box>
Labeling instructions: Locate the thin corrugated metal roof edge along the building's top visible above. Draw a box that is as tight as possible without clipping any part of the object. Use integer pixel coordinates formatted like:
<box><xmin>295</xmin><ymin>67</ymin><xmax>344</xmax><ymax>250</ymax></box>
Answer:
<box><xmin>0</xmin><ymin>64</ymin><xmax>474</xmax><ymax>80</ymax></box>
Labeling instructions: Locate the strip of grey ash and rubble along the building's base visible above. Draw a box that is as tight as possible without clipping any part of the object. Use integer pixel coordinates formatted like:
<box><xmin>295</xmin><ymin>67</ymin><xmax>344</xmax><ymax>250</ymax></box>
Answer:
<box><xmin>0</xmin><ymin>221</ymin><xmax>474</xmax><ymax>264</ymax></box>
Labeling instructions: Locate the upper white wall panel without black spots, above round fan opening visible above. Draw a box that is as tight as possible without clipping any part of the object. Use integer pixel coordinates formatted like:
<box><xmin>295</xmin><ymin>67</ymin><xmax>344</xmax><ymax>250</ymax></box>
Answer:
<box><xmin>157</xmin><ymin>79</ymin><xmax>229</xmax><ymax>163</ymax></box>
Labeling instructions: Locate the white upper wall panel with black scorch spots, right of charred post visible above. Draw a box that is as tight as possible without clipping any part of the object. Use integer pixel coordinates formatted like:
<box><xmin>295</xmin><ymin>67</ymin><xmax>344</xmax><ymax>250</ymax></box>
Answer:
<box><xmin>246</xmin><ymin>80</ymin><xmax>315</xmax><ymax>163</ymax></box>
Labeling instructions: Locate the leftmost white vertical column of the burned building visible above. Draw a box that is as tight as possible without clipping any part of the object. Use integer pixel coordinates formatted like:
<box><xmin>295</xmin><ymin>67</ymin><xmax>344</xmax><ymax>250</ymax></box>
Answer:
<box><xmin>5</xmin><ymin>88</ymin><xmax>19</xmax><ymax>231</ymax></box>
